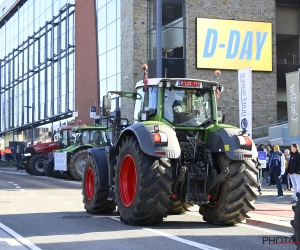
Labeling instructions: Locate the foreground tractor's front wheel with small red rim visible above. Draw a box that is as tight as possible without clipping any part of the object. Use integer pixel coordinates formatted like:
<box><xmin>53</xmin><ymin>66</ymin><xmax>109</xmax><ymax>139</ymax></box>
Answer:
<box><xmin>82</xmin><ymin>155</ymin><xmax>116</xmax><ymax>214</ymax></box>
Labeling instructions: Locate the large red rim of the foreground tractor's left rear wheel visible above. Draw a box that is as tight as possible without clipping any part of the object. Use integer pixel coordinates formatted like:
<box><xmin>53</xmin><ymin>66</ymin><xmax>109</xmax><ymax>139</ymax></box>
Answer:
<box><xmin>119</xmin><ymin>155</ymin><xmax>137</xmax><ymax>207</ymax></box>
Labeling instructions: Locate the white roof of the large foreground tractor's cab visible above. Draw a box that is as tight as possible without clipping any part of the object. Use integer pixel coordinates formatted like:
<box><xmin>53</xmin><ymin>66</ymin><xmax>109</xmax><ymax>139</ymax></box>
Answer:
<box><xmin>135</xmin><ymin>78</ymin><xmax>218</xmax><ymax>88</ymax></box>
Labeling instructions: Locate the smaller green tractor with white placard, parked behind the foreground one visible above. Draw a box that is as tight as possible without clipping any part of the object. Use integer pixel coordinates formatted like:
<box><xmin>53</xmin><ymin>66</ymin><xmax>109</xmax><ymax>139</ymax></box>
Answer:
<box><xmin>44</xmin><ymin>126</ymin><xmax>111</xmax><ymax>180</ymax></box>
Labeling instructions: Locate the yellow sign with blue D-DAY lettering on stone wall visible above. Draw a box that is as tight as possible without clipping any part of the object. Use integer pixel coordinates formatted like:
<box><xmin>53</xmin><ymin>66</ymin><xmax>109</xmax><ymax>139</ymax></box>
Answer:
<box><xmin>197</xmin><ymin>18</ymin><xmax>272</xmax><ymax>71</ymax></box>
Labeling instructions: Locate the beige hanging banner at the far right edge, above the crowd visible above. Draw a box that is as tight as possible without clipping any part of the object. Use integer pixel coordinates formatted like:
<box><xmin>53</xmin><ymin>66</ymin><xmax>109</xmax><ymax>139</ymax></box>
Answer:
<box><xmin>285</xmin><ymin>71</ymin><xmax>300</xmax><ymax>136</ymax></box>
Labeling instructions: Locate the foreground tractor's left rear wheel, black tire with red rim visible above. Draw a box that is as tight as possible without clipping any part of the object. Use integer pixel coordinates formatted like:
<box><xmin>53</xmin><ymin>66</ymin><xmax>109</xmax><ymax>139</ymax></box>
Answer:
<box><xmin>115</xmin><ymin>137</ymin><xmax>173</xmax><ymax>225</ymax></box>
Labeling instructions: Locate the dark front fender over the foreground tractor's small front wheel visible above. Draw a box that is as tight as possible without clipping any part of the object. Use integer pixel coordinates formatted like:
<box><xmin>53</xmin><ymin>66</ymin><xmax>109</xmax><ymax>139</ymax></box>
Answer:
<box><xmin>87</xmin><ymin>148</ymin><xmax>108</xmax><ymax>189</ymax></box>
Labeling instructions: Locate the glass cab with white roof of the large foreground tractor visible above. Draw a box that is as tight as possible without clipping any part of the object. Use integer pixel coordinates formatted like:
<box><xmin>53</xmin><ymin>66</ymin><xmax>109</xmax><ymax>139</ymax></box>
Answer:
<box><xmin>134</xmin><ymin>78</ymin><xmax>223</xmax><ymax>127</ymax></box>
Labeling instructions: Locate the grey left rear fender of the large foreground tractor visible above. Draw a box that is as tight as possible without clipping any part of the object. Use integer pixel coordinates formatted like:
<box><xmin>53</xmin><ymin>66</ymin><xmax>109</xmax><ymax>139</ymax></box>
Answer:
<box><xmin>116</xmin><ymin>122</ymin><xmax>181</xmax><ymax>159</ymax></box>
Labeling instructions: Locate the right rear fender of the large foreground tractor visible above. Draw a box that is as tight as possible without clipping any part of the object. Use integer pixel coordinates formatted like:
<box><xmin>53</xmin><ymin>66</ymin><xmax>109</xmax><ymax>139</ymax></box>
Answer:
<box><xmin>207</xmin><ymin>128</ymin><xmax>258</xmax><ymax>160</ymax></box>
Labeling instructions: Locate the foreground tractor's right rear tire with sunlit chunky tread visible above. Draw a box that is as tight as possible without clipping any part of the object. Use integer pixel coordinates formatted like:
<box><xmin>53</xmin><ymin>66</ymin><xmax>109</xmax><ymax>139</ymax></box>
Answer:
<box><xmin>199</xmin><ymin>153</ymin><xmax>259</xmax><ymax>225</ymax></box>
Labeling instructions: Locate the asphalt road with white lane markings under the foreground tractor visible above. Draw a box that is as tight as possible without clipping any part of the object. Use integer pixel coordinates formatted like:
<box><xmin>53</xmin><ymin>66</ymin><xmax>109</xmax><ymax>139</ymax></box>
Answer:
<box><xmin>0</xmin><ymin>170</ymin><xmax>296</xmax><ymax>250</ymax></box>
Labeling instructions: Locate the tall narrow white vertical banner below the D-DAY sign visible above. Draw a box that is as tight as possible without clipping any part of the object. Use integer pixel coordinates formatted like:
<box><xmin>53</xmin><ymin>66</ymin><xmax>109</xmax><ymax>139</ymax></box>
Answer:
<box><xmin>238</xmin><ymin>68</ymin><xmax>252</xmax><ymax>137</ymax></box>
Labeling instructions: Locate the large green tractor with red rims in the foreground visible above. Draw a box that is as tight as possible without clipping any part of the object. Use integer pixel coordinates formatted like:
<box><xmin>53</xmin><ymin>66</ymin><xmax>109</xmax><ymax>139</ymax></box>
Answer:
<box><xmin>82</xmin><ymin>66</ymin><xmax>258</xmax><ymax>225</ymax></box>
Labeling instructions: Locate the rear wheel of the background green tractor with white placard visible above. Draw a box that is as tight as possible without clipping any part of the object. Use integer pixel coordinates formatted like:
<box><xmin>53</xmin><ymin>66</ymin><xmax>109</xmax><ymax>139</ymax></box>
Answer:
<box><xmin>68</xmin><ymin>149</ymin><xmax>88</xmax><ymax>181</ymax></box>
